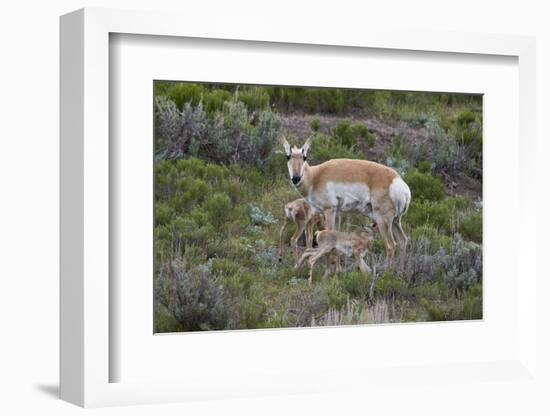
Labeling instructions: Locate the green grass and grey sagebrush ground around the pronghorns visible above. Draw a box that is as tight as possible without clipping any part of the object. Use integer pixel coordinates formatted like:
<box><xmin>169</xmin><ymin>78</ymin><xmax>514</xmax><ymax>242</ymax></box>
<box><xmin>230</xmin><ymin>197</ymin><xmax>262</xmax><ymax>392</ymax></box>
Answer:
<box><xmin>155</xmin><ymin>84</ymin><xmax>482</xmax><ymax>332</ymax></box>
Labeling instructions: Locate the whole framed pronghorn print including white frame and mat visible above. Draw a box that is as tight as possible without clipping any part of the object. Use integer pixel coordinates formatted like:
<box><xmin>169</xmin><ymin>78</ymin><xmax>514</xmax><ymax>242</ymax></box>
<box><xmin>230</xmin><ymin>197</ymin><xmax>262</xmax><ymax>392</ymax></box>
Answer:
<box><xmin>61</xmin><ymin>9</ymin><xmax>537</xmax><ymax>406</ymax></box>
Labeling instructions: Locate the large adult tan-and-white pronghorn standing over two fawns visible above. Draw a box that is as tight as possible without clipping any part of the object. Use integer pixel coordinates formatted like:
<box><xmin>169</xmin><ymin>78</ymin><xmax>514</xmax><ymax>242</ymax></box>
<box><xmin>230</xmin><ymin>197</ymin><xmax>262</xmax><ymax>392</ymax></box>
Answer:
<box><xmin>283</xmin><ymin>137</ymin><xmax>411</xmax><ymax>264</ymax></box>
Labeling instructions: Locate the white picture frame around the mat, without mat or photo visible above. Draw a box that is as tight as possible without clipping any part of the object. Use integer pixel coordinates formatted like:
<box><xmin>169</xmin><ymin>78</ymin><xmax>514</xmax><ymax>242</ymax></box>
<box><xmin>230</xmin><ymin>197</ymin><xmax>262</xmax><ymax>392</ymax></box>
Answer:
<box><xmin>60</xmin><ymin>9</ymin><xmax>538</xmax><ymax>407</ymax></box>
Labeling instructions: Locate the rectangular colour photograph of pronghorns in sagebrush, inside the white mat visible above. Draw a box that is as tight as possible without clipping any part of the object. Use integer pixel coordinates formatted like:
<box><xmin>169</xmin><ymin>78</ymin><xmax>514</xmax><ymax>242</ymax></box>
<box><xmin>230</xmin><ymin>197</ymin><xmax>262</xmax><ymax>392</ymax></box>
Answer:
<box><xmin>152</xmin><ymin>80</ymin><xmax>483</xmax><ymax>333</ymax></box>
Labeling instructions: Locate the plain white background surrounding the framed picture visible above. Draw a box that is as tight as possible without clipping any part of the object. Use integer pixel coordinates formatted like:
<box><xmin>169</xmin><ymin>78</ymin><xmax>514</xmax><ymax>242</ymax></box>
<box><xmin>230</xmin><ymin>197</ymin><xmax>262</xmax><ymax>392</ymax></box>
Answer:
<box><xmin>0</xmin><ymin>0</ymin><xmax>550</xmax><ymax>415</ymax></box>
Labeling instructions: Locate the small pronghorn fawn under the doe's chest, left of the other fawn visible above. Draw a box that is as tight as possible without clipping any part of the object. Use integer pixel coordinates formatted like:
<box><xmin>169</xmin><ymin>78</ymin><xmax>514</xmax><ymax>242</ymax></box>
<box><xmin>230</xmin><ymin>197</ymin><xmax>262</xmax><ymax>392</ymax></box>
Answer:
<box><xmin>279</xmin><ymin>198</ymin><xmax>325</xmax><ymax>261</ymax></box>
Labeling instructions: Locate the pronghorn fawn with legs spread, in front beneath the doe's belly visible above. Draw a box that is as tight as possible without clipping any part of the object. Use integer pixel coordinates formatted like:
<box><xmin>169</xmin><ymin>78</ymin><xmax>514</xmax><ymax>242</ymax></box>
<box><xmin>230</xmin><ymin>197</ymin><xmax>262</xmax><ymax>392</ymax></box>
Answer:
<box><xmin>296</xmin><ymin>226</ymin><xmax>374</xmax><ymax>284</ymax></box>
